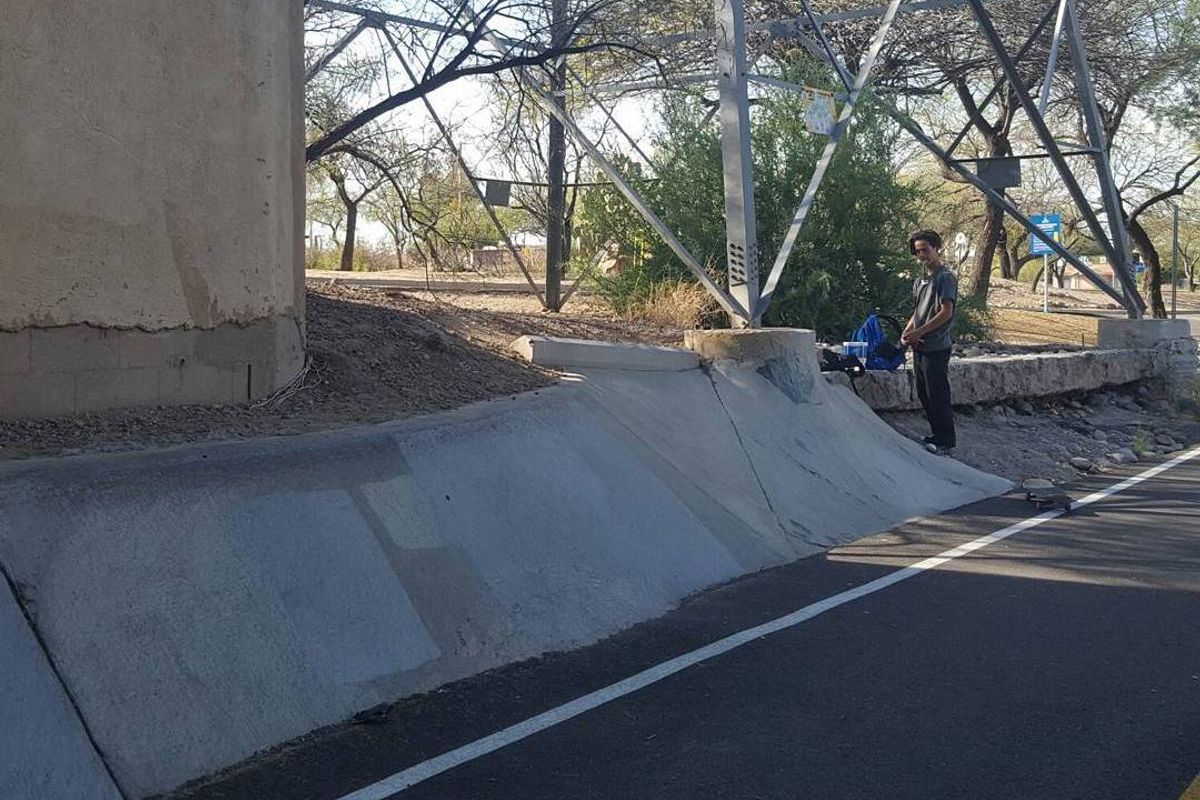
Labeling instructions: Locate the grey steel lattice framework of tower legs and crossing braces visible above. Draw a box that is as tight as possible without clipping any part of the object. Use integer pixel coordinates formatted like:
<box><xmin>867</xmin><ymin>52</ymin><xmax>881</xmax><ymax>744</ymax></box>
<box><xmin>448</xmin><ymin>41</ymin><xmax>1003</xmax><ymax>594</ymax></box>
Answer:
<box><xmin>307</xmin><ymin>0</ymin><xmax>1145</xmax><ymax>325</ymax></box>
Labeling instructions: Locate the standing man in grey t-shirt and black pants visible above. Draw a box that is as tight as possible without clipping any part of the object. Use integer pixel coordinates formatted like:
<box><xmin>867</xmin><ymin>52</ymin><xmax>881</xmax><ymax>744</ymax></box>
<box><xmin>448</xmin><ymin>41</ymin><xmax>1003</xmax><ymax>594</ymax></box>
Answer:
<box><xmin>900</xmin><ymin>230</ymin><xmax>959</xmax><ymax>456</ymax></box>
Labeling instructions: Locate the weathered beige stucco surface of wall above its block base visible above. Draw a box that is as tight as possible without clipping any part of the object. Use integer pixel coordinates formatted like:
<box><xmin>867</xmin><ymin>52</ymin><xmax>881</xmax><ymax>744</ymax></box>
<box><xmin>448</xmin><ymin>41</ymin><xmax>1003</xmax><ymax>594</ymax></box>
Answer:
<box><xmin>0</xmin><ymin>0</ymin><xmax>304</xmax><ymax>331</ymax></box>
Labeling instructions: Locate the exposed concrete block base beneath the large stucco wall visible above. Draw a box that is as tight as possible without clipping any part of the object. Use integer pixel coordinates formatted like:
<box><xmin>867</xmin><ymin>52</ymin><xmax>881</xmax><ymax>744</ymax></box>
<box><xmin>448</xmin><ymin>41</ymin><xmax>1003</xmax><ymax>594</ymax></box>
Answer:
<box><xmin>0</xmin><ymin>317</ymin><xmax>304</xmax><ymax>417</ymax></box>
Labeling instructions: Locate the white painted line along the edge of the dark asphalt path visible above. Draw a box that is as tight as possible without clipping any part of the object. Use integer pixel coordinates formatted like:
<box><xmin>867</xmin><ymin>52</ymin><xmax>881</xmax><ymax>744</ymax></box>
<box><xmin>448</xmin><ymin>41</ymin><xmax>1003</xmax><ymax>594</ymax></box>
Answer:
<box><xmin>338</xmin><ymin>447</ymin><xmax>1200</xmax><ymax>800</ymax></box>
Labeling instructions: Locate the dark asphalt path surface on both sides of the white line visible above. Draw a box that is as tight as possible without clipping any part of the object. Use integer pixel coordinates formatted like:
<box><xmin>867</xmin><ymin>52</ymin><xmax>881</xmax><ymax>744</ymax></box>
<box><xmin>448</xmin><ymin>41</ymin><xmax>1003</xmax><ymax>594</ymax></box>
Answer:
<box><xmin>182</xmin><ymin>458</ymin><xmax>1200</xmax><ymax>800</ymax></box>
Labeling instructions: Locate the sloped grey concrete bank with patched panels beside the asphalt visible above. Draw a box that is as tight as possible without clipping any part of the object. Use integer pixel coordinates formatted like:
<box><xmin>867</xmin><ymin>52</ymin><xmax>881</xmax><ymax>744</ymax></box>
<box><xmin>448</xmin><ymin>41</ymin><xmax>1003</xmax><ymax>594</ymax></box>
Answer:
<box><xmin>0</xmin><ymin>331</ymin><xmax>1008</xmax><ymax>800</ymax></box>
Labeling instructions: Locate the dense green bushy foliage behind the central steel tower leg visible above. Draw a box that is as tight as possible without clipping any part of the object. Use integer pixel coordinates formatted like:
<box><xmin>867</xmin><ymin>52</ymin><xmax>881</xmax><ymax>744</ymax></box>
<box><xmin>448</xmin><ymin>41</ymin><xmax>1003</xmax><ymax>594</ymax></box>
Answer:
<box><xmin>581</xmin><ymin>59</ymin><xmax>917</xmax><ymax>341</ymax></box>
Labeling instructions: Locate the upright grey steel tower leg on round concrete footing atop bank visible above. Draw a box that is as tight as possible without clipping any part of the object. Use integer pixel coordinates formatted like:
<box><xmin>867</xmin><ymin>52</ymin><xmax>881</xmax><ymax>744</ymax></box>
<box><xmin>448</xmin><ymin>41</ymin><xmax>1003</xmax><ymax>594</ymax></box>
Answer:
<box><xmin>716</xmin><ymin>0</ymin><xmax>760</xmax><ymax>327</ymax></box>
